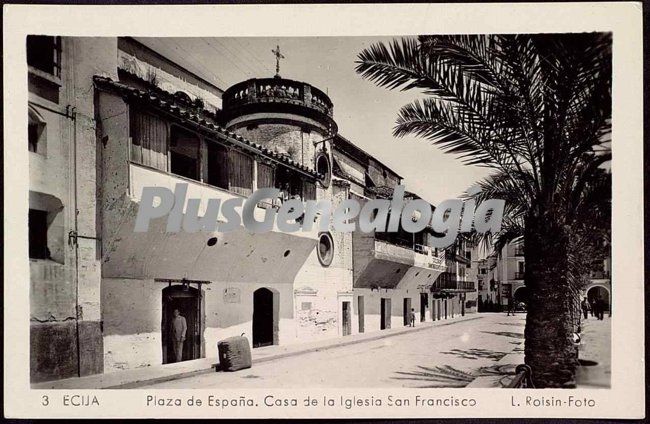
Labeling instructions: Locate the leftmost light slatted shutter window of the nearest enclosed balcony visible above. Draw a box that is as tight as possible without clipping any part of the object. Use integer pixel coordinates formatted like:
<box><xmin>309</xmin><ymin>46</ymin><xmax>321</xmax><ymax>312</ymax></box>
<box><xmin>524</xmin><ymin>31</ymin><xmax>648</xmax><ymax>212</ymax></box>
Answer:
<box><xmin>130</xmin><ymin>110</ymin><xmax>167</xmax><ymax>171</ymax></box>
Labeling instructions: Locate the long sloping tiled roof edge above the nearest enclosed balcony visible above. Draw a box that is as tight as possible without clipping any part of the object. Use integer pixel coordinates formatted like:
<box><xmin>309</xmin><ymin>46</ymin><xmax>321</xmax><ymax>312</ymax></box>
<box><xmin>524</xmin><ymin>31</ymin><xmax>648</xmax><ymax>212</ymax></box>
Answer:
<box><xmin>94</xmin><ymin>76</ymin><xmax>322</xmax><ymax>178</ymax></box>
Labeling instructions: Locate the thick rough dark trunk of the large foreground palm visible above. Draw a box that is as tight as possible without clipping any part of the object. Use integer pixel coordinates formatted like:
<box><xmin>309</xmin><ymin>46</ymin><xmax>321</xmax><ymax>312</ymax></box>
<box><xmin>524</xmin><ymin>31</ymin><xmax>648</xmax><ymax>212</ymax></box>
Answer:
<box><xmin>524</xmin><ymin>211</ymin><xmax>577</xmax><ymax>388</ymax></box>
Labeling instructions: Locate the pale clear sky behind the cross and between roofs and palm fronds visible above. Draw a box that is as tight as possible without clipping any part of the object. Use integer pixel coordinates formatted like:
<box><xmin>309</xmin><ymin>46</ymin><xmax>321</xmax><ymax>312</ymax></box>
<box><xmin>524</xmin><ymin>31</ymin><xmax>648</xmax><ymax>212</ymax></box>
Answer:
<box><xmin>137</xmin><ymin>37</ymin><xmax>488</xmax><ymax>204</ymax></box>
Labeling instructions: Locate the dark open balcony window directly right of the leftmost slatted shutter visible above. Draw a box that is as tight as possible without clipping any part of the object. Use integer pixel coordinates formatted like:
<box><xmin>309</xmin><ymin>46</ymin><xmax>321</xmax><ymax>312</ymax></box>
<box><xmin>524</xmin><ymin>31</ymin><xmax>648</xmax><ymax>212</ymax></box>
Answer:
<box><xmin>169</xmin><ymin>125</ymin><xmax>201</xmax><ymax>181</ymax></box>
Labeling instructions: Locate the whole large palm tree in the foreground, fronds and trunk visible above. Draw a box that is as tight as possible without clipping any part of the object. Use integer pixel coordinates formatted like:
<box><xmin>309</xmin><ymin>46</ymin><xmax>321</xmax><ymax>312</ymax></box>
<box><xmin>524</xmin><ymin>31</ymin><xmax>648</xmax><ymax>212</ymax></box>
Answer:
<box><xmin>356</xmin><ymin>33</ymin><xmax>611</xmax><ymax>387</ymax></box>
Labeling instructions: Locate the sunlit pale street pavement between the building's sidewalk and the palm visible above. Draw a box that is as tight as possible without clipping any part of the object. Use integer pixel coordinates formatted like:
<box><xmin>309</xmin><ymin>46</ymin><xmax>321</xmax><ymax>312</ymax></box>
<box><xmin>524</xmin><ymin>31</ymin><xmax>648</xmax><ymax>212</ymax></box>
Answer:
<box><xmin>141</xmin><ymin>313</ymin><xmax>525</xmax><ymax>389</ymax></box>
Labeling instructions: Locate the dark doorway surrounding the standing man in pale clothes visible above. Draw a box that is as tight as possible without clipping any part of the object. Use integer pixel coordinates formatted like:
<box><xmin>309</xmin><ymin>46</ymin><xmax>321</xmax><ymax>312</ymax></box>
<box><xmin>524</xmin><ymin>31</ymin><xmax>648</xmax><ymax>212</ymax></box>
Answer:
<box><xmin>161</xmin><ymin>285</ymin><xmax>202</xmax><ymax>364</ymax></box>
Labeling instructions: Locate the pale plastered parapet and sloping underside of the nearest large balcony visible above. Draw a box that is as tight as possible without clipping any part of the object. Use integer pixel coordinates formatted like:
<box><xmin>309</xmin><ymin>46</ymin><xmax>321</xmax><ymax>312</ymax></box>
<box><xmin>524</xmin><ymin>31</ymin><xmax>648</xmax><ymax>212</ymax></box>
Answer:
<box><xmin>102</xmin><ymin>163</ymin><xmax>318</xmax><ymax>283</ymax></box>
